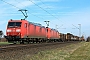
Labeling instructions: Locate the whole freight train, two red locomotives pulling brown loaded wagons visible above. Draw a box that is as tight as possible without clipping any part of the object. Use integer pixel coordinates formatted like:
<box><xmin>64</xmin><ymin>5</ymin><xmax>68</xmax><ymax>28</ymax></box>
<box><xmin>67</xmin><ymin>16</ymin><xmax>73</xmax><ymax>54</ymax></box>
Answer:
<box><xmin>5</xmin><ymin>19</ymin><xmax>83</xmax><ymax>44</ymax></box>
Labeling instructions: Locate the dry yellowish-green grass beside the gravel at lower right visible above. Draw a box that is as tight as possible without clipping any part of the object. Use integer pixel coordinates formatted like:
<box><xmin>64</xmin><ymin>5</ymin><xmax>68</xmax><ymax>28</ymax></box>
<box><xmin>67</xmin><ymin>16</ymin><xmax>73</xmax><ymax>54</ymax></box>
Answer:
<box><xmin>23</xmin><ymin>42</ymin><xmax>90</xmax><ymax>60</ymax></box>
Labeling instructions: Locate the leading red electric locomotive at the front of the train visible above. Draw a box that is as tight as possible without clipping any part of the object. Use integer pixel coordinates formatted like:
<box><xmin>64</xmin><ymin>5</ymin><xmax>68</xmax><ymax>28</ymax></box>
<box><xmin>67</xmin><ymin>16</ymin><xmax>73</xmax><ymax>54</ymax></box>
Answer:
<box><xmin>5</xmin><ymin>20</ymin><xmax>47</xmax><ymax>43</ymax></box>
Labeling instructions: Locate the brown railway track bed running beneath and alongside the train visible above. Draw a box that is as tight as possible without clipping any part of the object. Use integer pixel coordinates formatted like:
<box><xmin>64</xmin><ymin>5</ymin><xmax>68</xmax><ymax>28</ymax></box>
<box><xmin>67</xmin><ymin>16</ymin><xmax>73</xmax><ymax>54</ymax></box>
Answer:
<box><xmin>0</xmin><ymin>41</ymin><xmax>80</xmax><ymax>53</ymax></box>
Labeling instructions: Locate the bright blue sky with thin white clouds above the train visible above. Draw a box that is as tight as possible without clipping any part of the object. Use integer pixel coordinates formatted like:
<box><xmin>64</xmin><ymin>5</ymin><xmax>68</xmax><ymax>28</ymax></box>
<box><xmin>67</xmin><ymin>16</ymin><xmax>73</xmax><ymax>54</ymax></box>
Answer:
<box><xmin>0</xmin><ymin>0</ymin><xmax>90</xmax><ymax>37</ymax></box>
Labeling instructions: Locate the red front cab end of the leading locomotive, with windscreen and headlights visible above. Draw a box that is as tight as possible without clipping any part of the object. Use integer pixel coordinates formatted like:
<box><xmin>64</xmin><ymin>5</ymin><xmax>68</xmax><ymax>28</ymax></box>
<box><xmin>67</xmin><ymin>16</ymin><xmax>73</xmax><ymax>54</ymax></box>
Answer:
<box><xmin>5</xmin><ymin>19</ymin><xmax>28</xmax><ymax>42</ymax></box>
